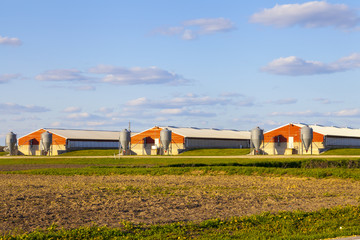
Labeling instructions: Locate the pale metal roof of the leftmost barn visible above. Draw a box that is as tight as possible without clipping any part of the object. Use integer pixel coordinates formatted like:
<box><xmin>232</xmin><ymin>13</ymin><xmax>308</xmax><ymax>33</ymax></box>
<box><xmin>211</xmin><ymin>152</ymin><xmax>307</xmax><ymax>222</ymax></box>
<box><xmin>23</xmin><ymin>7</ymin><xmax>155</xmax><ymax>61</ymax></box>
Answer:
<box><xmin>44</xmin><ymin>128</ymin><xmax>120</xmax><ymax>141</ymax></box>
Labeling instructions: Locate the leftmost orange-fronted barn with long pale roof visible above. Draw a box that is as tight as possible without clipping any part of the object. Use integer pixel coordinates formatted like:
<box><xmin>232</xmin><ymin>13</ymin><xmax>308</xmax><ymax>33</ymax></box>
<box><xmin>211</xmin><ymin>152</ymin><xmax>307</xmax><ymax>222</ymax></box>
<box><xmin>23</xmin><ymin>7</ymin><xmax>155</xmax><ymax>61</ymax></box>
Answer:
<box><xmin>18</xmin><ymin>128</ymin><xmax>120</xmax><ymax>155</ymax></box>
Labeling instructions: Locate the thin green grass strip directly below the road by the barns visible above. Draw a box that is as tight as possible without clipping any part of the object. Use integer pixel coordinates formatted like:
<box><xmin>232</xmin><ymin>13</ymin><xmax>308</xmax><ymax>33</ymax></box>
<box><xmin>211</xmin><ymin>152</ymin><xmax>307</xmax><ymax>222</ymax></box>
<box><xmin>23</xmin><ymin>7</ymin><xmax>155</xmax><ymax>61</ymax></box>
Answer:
<box><xmin>0</xmin><ymin>157</ymin><xmax>360</xmax><ymax>168</ymax></box>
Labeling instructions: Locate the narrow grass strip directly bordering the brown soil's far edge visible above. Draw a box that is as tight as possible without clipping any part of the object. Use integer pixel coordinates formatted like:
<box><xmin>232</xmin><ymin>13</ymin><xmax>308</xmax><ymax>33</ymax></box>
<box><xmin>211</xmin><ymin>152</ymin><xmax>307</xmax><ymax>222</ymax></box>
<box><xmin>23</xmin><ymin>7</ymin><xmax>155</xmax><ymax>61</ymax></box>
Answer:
<box><xmin>0</xmin><ymin>166</ymin><xmax>360</xmax><ymax>180</ymax></box>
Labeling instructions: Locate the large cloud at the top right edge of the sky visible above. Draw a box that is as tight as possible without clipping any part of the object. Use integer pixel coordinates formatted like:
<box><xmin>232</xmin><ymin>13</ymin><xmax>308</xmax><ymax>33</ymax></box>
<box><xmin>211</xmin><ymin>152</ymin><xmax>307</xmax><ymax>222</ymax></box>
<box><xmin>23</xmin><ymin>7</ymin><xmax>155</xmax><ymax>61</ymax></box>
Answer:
<box><xmin>250</xmin><ymin>1</ymin><xmax>359</xmax><ymax>29</ymax></box>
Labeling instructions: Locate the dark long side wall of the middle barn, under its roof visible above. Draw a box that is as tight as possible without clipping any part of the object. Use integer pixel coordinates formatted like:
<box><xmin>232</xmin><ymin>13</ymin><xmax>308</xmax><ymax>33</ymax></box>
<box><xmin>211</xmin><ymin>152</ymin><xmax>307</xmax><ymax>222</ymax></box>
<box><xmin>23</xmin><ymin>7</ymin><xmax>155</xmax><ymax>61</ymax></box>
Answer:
<box><xmin>185</xmin><ymin>138</ymin><xmax>250</xmax><ymax>149</ymax></box>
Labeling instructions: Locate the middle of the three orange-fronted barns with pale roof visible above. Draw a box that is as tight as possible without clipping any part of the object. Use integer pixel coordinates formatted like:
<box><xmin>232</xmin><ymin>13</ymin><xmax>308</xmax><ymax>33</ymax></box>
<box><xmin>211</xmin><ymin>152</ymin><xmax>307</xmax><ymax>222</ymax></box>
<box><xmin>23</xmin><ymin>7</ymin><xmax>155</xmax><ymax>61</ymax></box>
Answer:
<box><xmin>131</xmin><ymin>126</ymin><xmax>250</xmax><ymax>155</ymax></box>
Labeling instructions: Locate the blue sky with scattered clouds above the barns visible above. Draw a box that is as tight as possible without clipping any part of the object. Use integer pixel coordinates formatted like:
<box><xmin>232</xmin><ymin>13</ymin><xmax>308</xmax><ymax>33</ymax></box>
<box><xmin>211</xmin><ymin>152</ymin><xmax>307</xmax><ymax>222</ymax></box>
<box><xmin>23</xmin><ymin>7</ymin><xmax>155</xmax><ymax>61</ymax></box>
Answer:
<box><xmin>0</xmin><ymin>0</ymin><xmax>360</xmax><ymax>144</ymax></box>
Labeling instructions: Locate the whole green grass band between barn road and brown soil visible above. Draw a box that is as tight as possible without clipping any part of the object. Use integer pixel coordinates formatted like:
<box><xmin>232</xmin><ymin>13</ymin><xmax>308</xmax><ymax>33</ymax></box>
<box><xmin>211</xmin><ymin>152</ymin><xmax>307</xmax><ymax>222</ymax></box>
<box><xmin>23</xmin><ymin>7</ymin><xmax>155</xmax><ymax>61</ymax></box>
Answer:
<box><xmin>0</xmin><ymin>157</ymin><xmax>360</xmax><ymax>180</ymax></box>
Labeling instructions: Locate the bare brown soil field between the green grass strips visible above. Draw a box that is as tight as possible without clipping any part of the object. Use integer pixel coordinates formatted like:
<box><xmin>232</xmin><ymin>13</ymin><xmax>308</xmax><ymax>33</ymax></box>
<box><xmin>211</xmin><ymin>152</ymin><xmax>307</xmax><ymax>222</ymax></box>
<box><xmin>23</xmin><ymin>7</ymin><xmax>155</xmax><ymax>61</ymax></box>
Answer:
<box><xmin>0</xmin><ymin>173</ymin><xmax>360</xmax><ymax>232</ymax></box>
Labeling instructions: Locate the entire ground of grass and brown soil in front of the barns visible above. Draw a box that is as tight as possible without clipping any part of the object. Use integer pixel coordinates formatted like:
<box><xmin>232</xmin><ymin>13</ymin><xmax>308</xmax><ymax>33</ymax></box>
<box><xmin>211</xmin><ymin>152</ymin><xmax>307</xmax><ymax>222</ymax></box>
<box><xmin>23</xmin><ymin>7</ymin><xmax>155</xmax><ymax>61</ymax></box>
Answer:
<box><xmin>0</xmin><ymin>152</ymin><xmax>360</xmax><ymax>239</ymax></box>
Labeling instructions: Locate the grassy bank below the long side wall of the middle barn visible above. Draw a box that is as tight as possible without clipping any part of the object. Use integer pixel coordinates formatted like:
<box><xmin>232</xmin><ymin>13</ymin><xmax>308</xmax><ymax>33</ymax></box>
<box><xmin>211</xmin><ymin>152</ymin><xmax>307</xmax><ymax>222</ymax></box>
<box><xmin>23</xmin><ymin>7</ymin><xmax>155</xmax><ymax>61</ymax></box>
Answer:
<box><xmin>180</xmin><ymin>148</ymin><xmax>250</xmax><ymax>156</ymax></box>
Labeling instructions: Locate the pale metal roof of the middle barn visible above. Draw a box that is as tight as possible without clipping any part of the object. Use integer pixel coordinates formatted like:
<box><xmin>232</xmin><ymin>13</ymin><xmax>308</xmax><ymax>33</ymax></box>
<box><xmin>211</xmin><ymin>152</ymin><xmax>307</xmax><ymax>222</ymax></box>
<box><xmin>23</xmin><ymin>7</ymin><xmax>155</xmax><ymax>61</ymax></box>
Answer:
<box><xmin>160</xmin><ymin>126</ymin><xmax>251</xmax><ymax>139</ymax></box>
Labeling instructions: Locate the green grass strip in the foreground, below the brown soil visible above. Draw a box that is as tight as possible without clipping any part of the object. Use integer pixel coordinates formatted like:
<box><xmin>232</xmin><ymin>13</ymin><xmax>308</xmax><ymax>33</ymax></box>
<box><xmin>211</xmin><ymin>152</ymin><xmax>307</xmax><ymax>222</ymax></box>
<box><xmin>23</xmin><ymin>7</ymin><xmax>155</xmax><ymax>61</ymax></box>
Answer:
<box><xmin>2</xmin><ymin>206</ymin><xmax>360</xmax><ymax>240</ymax></box>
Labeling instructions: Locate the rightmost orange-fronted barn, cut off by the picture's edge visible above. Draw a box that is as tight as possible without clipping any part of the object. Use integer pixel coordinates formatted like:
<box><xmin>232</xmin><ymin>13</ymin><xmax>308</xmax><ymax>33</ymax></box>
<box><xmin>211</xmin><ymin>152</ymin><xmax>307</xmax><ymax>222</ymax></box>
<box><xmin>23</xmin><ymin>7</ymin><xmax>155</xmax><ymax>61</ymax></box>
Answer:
<box><xmin>263</xmin><ymin>123</ymin><xmax>360</xmax><ymax>155</ymax></box>
